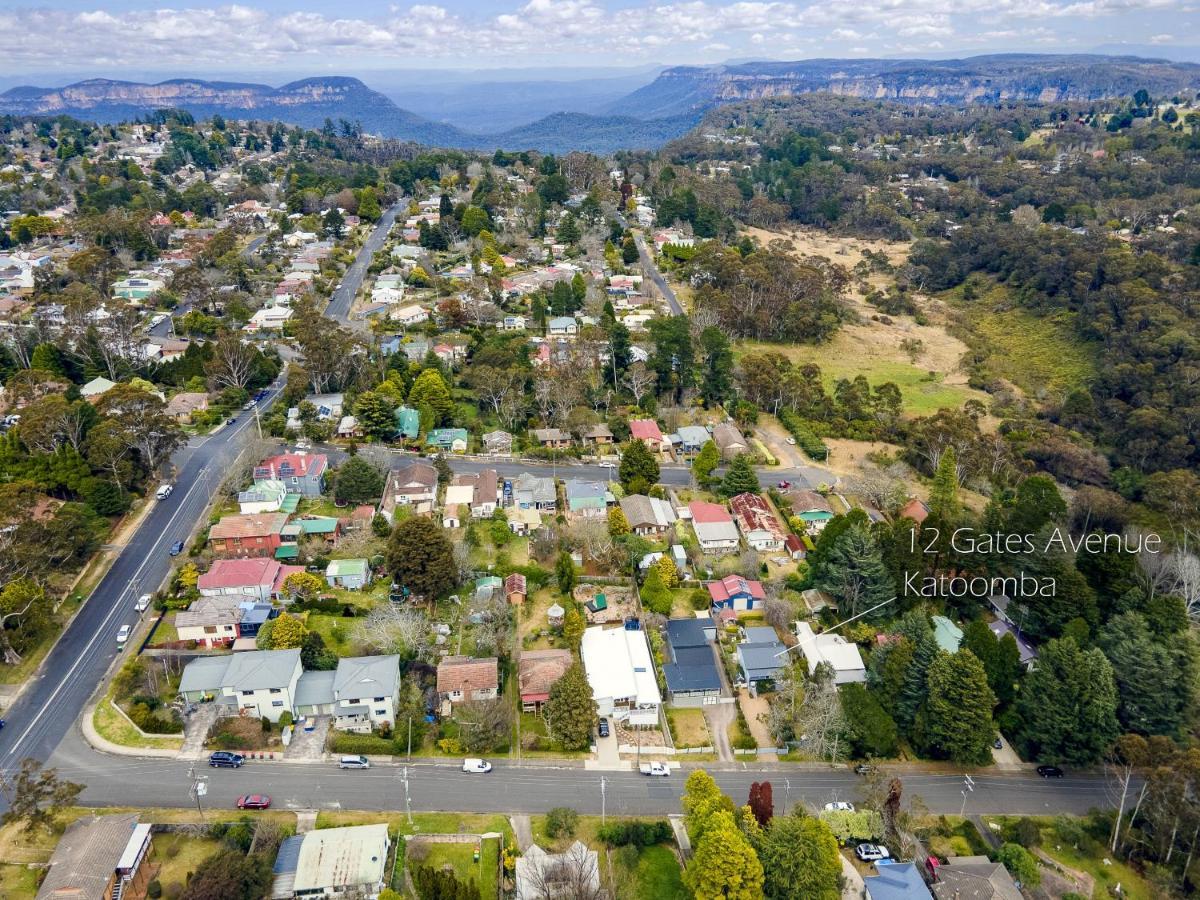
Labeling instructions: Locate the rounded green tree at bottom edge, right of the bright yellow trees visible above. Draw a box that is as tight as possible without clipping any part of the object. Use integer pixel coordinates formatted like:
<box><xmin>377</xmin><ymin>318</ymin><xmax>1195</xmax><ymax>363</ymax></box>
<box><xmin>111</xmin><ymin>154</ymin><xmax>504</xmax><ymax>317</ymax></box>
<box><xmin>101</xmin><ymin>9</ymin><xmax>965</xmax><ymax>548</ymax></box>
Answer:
<box><xmin>756</xmin><ymin>815</ymin><xmax>841</xmax><ymax>900</ymax></box>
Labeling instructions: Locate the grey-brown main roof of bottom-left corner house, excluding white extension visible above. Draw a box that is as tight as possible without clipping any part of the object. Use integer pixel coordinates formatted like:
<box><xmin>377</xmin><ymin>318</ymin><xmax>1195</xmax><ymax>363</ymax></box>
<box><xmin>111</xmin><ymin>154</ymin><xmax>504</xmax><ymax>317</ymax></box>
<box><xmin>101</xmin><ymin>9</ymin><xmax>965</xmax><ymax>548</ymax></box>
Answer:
<box><xmin>37</xmin><ymin>814</ymin><xmax>138</xmax><ymax>900</ymax></box>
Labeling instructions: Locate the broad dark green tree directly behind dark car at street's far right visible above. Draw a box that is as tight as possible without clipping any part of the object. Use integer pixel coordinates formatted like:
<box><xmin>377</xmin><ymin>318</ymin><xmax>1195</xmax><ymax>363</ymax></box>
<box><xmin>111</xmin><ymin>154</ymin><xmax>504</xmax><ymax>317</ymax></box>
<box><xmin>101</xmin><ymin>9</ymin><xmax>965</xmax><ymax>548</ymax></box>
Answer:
<box><xmin>1016</xmin><ymin>637</ymin><xmax>1118</xmax><ymax>766</ymax></box>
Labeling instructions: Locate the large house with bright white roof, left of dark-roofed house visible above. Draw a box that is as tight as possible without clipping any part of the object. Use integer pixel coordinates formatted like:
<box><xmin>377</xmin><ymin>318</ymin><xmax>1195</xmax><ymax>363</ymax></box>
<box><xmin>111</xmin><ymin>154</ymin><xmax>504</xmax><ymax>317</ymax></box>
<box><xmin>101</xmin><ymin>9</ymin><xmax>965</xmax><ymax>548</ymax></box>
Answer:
<box><xmin>580</xmin><ymin>625</ymin><xmax>662</xmax><ymax>728</ymax></box>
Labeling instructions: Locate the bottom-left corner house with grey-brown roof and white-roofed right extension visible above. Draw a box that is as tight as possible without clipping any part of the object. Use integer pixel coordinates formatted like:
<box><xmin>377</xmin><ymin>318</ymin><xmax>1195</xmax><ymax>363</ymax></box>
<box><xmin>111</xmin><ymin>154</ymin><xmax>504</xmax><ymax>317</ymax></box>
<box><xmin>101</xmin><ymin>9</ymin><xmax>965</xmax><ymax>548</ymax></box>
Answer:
<box><xmin>35</xmin><ymin>812</ymin><xmax>157</xmax><ymax>900</ymax></box>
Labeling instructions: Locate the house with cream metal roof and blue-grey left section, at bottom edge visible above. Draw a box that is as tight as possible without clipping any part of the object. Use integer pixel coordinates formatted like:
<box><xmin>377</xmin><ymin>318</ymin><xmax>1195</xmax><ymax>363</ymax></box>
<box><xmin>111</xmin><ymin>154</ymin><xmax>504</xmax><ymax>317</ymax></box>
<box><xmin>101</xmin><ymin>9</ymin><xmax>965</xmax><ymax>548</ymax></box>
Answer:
<box><xmin>270</xmin><ymin>823</ymin><xmax>391</xmax><ymax>900</ymax></box>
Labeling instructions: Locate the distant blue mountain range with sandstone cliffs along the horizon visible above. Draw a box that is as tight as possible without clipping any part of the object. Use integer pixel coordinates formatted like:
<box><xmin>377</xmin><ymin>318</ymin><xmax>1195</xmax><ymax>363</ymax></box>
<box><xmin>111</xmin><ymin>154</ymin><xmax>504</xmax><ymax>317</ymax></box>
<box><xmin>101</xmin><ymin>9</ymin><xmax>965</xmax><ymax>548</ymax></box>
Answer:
<box><xmin>0</xmin><ymin>54</ymin><xmax>1200</xmax><ymax>154</ymax></box>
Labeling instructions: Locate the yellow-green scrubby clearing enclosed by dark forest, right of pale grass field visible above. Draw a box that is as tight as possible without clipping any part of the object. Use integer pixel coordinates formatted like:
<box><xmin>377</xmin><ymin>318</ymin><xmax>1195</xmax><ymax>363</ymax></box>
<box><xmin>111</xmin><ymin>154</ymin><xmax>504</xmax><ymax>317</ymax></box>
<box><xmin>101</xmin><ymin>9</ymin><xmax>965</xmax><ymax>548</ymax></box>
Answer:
<box><xmin>947</xmin><ymin>286</ymin><xmax>1097</xmax><ymax>397</ymax></box>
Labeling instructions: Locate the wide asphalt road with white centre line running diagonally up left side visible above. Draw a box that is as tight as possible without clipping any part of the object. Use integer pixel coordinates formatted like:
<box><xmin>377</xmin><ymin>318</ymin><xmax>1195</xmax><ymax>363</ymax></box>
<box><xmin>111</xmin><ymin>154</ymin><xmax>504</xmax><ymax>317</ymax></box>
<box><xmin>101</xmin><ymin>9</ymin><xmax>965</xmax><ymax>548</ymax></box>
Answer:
<box><xmin>0</xmin><ymin>383</ymin><xmax>282</xmax><ymax>769</ymax></box>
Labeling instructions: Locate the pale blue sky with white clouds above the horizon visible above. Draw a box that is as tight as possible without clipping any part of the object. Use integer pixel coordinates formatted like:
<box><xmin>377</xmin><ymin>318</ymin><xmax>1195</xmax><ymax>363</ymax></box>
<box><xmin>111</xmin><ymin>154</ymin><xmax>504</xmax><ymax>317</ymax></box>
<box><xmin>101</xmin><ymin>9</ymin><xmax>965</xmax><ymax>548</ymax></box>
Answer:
<box><xmin>0</xmin><ymin>0</ymin><xmax>1200</xmax><ymax>83</ymax></box>
